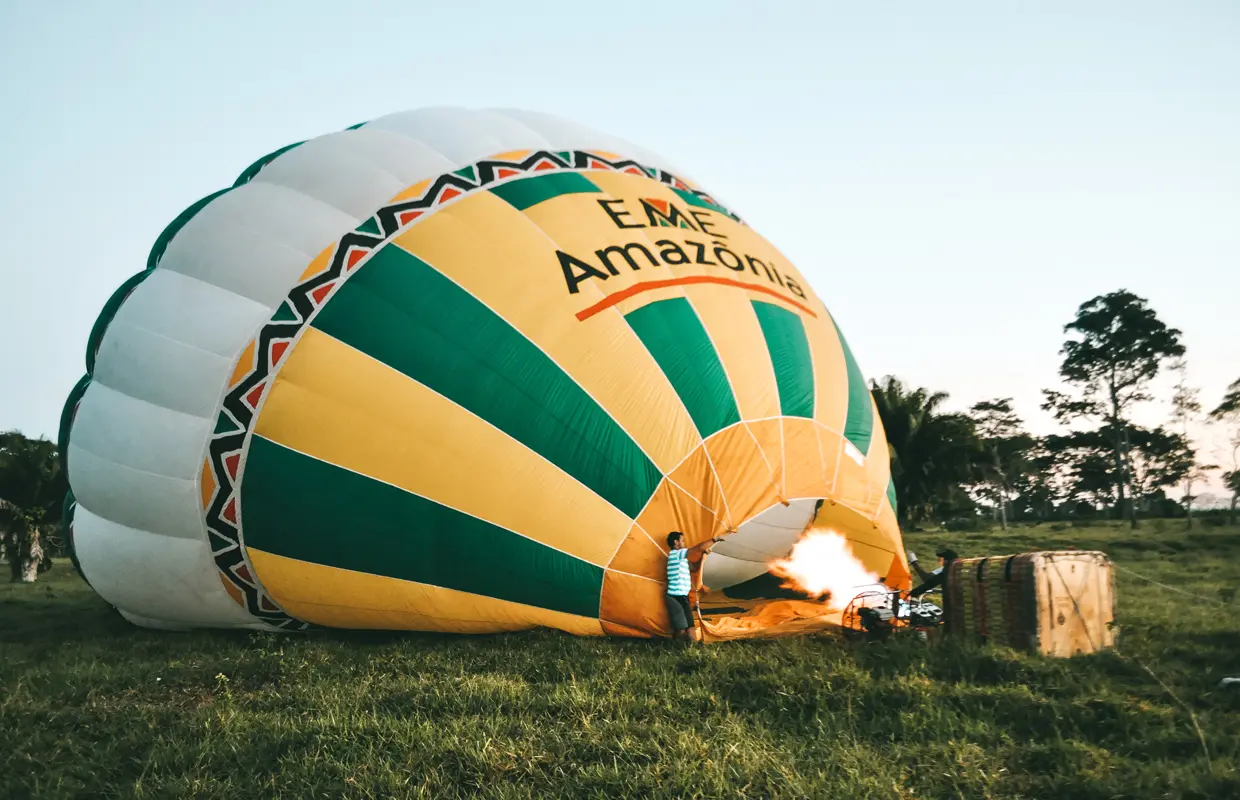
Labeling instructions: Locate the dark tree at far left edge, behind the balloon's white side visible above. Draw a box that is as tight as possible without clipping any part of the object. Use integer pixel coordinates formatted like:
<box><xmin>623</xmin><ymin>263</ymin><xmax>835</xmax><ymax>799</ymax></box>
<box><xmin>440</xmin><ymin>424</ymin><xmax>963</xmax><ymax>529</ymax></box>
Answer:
<box><xmin>0</xmin><ymin>430</ymin><xmax>68</xmax><ymax>583</ymax></box>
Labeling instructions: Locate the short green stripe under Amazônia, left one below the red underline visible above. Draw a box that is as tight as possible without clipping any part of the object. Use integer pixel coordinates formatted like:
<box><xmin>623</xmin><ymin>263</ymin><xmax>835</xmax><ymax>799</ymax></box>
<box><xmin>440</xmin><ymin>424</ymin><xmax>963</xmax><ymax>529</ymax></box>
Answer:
<box><xmin>625</xmin><ymin>298</ymin><xmax>740</xmax><ymax>439</ymax></box>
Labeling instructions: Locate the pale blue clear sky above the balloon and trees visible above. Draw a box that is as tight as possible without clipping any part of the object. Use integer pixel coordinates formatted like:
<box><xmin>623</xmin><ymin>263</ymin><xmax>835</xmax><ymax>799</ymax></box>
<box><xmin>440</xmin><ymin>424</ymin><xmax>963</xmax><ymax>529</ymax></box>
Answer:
<box><xmin>0</xmin><ymin>0</ymin><xmax>1240</xmax><ymax>493</ymax></box>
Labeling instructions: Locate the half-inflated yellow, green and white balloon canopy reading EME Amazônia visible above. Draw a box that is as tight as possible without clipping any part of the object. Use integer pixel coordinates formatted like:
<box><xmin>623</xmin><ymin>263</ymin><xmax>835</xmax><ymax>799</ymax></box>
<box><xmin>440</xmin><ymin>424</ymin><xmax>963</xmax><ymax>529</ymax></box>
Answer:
<box><xmin>61</xmin><ymin>109</ymin><xmax>909</xmax><ymax>638</ymax></box>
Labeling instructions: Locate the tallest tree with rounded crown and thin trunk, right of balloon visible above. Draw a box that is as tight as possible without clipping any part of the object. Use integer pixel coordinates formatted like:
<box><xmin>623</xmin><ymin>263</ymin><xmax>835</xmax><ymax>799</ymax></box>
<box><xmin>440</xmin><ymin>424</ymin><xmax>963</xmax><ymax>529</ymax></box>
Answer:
<box><xmin>1043</xmin><ymin>289</ymin><xmax>1184</xmax><ymax>527</ymax></box>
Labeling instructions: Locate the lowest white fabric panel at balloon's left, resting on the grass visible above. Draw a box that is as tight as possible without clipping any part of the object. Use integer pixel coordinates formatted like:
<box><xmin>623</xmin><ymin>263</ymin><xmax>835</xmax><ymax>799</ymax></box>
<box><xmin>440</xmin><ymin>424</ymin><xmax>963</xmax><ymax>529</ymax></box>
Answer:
<box><xmin>73</xmin><ymin>508</ymin><xmax>255</xmax><ymax>628</ymax></box>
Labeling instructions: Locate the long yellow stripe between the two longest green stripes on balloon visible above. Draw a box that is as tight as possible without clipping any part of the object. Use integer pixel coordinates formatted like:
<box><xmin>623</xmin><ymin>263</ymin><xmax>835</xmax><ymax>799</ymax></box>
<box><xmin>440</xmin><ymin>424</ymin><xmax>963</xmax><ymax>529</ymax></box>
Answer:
<box><xmin>255</xmin><ymin>327</ymin><xmax>632</xmax><ymax>567</ymax></box>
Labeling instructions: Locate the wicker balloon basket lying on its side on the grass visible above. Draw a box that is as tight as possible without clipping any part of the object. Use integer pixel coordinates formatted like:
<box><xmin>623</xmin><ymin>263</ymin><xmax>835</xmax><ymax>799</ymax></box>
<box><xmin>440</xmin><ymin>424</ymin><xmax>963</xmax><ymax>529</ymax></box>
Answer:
<box><xmin>944</xmin><ymin>551</ymin><xmax>1116</xmax><ymax>656</ymax></box>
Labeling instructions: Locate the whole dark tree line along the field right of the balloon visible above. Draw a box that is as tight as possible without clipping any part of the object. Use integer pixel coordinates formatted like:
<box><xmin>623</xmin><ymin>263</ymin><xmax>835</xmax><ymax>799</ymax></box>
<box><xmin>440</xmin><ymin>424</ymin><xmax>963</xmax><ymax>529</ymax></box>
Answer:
<box><xmin>870</xmin><ymin>290</ymin><xmax>1240</xmax><ymax>527</ymax></box>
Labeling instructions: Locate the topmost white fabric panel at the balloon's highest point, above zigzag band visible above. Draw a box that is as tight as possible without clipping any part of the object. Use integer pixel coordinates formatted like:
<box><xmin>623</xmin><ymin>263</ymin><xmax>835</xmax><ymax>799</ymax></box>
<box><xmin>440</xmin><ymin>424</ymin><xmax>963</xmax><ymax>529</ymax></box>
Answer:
<box><xmin>362</xmin><ymin>108</ymin><xmax>547</xmax><ymax>167</ymax></box>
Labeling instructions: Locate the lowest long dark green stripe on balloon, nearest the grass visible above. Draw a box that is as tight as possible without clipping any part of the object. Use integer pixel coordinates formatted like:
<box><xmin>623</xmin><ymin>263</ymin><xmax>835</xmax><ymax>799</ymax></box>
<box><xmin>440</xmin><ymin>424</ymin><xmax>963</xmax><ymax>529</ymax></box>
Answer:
<box><xmin>242</xmin><ymin>437</ymin><xmax>603</xmax><ymax>618</ymax></box>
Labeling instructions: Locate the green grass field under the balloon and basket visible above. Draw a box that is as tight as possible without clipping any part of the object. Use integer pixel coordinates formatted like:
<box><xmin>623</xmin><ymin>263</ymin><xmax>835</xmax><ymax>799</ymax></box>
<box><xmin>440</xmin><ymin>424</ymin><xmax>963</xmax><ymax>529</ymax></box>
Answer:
<box><xmin>0</xmin><ymin>522</ymin><xmax>1240</xmax><ymax>799</ymax></box>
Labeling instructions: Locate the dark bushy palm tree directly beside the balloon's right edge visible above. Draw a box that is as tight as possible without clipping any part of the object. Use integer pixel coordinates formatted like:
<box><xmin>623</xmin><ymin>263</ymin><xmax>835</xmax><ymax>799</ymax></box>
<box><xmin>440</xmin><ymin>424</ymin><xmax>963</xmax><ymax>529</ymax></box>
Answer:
<box><xmin>870</xmin><ymin>376</ymin><xmax>980</xmax><ymax>527</ymax></box>
